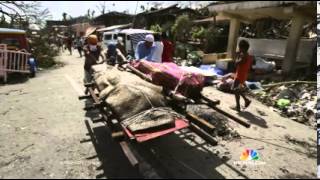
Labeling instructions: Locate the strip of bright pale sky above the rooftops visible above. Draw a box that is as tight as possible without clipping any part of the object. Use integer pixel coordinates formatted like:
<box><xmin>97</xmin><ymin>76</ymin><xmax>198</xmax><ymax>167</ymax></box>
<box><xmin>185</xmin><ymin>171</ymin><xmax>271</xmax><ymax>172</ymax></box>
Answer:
<box><xmin>41</xmin><ymin>1</ymin><xmax>176</xmax><ymax>20</ymax></box>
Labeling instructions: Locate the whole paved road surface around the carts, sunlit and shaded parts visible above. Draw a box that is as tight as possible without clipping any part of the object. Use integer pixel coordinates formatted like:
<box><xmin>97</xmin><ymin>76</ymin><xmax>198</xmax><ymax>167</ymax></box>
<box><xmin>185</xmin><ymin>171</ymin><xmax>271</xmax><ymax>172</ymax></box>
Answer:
<box><xmin>0</xmin><ymin>53</ymin><xmax>316</xmax><ymax>178</ymax></box>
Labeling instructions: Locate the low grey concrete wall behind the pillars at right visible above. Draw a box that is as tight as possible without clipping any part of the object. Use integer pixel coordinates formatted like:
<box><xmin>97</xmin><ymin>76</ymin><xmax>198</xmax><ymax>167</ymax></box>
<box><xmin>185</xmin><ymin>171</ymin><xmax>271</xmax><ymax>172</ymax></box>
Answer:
<box><xmin>237</xmin><ymin>37</ymin><xmax>316</xmax><ymax>63</ymax></box>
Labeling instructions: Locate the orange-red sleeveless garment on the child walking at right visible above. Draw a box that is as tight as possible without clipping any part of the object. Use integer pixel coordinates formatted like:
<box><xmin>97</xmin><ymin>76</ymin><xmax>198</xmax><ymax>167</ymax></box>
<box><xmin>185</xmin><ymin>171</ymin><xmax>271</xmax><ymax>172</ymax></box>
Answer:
<box><xmin>235</xmin><ymin>55</ymin><xmax>253</xmax><ymax>84</ymax></box>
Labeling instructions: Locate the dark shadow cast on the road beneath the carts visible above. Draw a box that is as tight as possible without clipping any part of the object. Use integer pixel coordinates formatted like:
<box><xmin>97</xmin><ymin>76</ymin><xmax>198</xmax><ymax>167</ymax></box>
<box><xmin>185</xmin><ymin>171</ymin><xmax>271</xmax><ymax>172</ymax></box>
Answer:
<box><xmin>80</xmin><ymin>100</ymin><xmax>248</xmax><ymax>179</ymax></box>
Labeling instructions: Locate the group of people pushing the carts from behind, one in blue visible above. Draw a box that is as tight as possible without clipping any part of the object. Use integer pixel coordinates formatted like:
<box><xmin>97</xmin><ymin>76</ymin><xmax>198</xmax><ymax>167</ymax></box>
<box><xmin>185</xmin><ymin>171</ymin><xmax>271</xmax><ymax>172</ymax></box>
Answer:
<box><xmin>81</xmin><ymin>33</ymin><xmax>173</xmax><ymax>83</ymax></box>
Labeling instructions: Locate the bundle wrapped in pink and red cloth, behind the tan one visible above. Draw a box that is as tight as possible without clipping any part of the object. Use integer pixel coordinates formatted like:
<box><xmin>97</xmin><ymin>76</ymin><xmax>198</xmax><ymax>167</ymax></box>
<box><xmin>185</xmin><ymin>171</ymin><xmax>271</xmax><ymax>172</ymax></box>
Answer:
<box><xmin>131</xmin><ymin>60</ymin><xmax>205</xmax><ymax>98</ymax></box>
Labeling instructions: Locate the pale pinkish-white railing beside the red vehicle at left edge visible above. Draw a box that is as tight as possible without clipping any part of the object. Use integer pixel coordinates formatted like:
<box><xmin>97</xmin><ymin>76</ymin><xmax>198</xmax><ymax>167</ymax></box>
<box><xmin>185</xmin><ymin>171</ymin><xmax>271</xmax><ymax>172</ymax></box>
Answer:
<box><xmin>0</xmin><ymin>44</ymin><xmax>30</xmax><ymax>82</ymax></box>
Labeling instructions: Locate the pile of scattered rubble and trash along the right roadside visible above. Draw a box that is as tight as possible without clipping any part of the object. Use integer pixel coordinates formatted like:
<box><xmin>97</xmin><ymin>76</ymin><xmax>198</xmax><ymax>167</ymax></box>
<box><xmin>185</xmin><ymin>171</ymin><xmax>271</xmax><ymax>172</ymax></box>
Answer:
<box><xmin>253</xmin><ymin>81</ymin><xmax>317</xmax><ymax>127</ymax></box>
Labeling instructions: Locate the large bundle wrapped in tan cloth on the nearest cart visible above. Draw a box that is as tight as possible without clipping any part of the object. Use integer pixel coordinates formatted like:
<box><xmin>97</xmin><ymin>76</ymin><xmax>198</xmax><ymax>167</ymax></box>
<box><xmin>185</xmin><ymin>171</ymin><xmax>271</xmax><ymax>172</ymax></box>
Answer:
<box><xmin>93</xmin><ymin>64</ymin><xmax>185</xmax><ymax>132</ymax></box>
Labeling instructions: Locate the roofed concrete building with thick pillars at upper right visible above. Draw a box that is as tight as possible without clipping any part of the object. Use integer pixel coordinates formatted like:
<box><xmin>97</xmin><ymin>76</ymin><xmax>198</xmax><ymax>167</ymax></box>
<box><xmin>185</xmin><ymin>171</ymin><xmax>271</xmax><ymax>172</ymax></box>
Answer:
<box><xmin>208</xmin><ymin>1</ymin><xmax>316</xmax><ymax>74</ymax></box>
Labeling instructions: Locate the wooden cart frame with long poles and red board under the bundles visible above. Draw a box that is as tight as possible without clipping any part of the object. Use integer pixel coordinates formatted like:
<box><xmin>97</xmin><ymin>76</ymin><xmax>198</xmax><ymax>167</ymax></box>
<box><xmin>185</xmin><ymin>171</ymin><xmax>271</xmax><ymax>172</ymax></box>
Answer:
<box><xmin>79</xmin><ymin>64</ymin><xmax>250</xmax><ymax>169</ymax></box>
